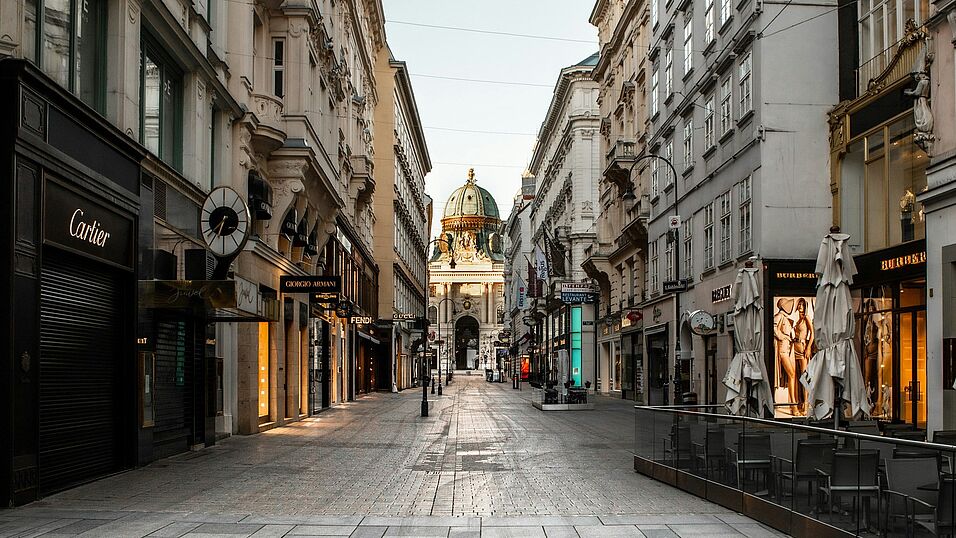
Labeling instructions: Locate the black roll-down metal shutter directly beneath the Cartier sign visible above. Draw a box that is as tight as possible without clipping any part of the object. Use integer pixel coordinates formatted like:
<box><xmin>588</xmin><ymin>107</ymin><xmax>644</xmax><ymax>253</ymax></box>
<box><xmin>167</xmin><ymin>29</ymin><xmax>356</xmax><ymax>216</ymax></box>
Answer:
<box><xmin>39</xmin><ymin>249</ymin><xmax>124</xmax><ymax>495</ymax></box>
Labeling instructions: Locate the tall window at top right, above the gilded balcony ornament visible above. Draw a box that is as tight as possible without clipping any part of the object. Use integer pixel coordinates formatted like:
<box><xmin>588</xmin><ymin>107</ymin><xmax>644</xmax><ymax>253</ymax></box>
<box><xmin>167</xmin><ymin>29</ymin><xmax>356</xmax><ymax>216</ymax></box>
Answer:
<box><xmin>859</xmin><ymin>0</ymin><xmax>929</xmax><ymax>66</ymax></box>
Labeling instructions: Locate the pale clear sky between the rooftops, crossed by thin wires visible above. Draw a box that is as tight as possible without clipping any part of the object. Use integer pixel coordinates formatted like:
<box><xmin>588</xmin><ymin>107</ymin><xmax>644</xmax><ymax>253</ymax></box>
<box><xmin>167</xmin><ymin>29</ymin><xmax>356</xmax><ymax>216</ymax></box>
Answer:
<box><xmin>383</xmin><ymin>0</ymin><xmax>598</xmax><ymax>237</ymax></box>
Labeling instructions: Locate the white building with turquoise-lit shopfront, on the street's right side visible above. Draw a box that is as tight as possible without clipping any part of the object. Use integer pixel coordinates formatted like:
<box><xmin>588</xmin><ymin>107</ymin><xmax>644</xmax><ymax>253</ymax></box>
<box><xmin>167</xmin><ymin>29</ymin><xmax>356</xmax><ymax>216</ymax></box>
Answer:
<box><xmin>524</xmin><ymin>54</ymin><xmax>601</xmax><ymax>386</ymax></box>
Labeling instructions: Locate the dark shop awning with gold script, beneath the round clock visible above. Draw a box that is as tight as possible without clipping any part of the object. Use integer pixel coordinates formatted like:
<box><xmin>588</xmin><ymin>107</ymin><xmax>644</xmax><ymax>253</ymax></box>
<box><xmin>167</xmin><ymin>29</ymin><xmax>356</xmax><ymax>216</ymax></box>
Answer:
<box><xmin>139</xmin><ymin>277</ymin><xmax>279</xmax><ymax>321</ymax></box>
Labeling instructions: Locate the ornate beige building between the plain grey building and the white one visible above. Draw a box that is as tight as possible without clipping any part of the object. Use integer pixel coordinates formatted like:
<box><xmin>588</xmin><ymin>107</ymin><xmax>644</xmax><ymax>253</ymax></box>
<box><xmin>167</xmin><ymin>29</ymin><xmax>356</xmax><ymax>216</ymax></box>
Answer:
<box><xmin>584</xmin><ymin>0</ymin><xmax>650</xmax><ymax>401</ymax></box>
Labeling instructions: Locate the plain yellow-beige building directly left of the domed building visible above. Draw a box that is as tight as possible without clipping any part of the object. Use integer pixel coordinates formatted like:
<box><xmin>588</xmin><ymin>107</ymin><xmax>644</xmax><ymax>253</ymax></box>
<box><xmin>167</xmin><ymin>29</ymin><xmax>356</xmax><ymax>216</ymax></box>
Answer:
<box><xmin>374</xmin><ymin>48</ymin><xmax>432</xmax><ymax>390</ymax></box>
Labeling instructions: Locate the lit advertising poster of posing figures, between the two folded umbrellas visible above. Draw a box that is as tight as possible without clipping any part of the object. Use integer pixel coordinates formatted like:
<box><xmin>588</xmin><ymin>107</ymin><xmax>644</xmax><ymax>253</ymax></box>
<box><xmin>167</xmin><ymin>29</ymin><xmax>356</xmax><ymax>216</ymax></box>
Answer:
<box><xmin>771</xmin><ymin>297</ymin><xmax>816</xmax><ymax>416</ymax></box>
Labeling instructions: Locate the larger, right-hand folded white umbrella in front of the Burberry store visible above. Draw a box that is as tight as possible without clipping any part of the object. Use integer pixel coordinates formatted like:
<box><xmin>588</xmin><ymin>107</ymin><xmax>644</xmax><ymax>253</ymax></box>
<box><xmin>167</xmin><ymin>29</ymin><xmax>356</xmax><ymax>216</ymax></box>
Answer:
<box><xmin>800</xmin><ymin>227</ymin><xmax>873</xmax><ymax>420</ymax></box>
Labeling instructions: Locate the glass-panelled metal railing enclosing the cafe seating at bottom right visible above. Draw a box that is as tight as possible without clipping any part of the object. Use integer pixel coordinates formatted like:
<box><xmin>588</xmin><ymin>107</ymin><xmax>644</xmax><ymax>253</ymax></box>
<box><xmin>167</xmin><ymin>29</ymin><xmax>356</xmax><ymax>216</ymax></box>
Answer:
<box><xmin>634</xmin><ymin>405</ymin><xmax>956</xmax><ymax>536</ymax></box>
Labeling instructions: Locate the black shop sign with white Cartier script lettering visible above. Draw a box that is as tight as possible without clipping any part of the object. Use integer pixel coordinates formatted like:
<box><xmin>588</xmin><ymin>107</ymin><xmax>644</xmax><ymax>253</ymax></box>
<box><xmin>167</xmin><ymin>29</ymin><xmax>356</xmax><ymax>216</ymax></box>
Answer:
<box><xmin>43</xmin><ymin>181</ymin><xmax>133</xmax><ymax>268</ymax></box>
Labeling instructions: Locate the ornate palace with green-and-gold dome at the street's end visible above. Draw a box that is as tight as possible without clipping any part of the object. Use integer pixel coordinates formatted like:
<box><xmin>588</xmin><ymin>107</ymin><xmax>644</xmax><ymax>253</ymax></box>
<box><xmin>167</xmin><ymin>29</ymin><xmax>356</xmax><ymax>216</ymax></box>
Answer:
<box><xmin>428</xmin><ymin>169</ymin><xmax>504</xmax><ymax>372</ymax></box>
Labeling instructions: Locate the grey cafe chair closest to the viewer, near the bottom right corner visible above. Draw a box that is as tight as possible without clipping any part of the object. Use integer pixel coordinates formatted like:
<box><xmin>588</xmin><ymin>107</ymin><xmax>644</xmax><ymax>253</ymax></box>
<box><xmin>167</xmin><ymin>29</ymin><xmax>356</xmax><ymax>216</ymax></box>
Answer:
<box><xmin>881</xmin><ymin>458</ymin><xmax>939</xmax><ymax>536</ymax></box>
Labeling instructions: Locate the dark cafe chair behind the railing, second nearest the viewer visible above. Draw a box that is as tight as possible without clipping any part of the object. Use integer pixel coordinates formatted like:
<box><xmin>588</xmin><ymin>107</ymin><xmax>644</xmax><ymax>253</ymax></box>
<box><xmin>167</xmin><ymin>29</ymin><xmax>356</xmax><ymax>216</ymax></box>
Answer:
<box><xmin>817</xmin><ymin>450</ymin><xmax>880</xmax><ymax>527</ymax></box>
